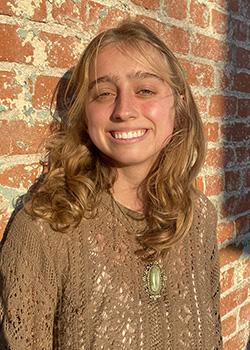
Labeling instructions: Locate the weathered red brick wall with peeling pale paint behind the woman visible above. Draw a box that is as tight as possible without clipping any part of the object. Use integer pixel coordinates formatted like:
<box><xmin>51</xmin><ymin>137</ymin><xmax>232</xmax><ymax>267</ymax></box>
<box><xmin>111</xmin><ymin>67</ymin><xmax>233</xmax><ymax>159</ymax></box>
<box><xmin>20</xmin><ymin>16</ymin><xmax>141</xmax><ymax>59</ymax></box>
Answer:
<box><xmin>0</xmin><ymin>0</ymin><xmax>250</xmax><ymax>350</ymax></box>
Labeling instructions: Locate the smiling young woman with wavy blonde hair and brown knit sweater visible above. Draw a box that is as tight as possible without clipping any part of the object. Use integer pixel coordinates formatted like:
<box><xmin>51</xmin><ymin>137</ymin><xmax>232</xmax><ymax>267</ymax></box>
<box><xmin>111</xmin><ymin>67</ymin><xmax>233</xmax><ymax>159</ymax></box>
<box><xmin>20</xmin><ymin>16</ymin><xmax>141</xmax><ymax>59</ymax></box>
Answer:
<box><xmin>0</xmin><ymin>21</ymin><xmax>222</xmax><ymax>350</ymax></box>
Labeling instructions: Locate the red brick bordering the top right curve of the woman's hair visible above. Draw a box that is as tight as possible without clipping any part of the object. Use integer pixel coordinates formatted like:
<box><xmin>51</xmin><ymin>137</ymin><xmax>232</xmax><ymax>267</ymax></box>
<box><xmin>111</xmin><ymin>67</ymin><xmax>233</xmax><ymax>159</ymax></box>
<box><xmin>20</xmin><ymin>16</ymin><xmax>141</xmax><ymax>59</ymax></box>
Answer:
<box><xmin>136</xmin><ymin>16</ymin><xmax>190</xmax><ymax>55</ymax></box>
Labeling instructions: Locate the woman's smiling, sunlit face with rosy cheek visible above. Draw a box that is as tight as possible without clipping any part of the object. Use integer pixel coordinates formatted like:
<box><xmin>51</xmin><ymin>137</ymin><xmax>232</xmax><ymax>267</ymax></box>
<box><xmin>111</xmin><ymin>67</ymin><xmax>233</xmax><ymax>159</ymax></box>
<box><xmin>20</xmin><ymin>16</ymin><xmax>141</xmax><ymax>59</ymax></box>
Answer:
<box><xmin>86</xmin><ymin>46</ymin><xmax>174</xmax><ymax>171</ymax></box>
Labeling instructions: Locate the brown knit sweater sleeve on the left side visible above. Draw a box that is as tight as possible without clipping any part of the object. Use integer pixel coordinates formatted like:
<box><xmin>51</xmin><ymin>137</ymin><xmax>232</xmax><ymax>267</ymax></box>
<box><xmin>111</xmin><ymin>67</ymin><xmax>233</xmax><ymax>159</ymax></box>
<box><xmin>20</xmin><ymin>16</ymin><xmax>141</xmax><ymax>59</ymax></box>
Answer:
<box><xmin>0</xmin><ymin>210</ymin><xmax>66</xmax><ymax>350</ymax></box>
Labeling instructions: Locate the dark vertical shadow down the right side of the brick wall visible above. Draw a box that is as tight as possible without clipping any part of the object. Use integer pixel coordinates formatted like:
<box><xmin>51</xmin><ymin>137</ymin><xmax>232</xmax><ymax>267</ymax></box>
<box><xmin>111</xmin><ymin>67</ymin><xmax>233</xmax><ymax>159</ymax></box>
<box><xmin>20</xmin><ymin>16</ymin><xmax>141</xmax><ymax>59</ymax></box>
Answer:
<box><xmin>221</xmin><ymin>0</ymin><xmax>250</xmax><ymax>350</ymax></box>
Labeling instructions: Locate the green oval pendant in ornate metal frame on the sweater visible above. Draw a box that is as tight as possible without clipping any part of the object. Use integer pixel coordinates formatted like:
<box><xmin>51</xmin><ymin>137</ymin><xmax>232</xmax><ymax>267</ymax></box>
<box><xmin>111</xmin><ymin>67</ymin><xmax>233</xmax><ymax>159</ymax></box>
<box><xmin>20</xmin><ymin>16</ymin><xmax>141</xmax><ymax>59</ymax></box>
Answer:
<box><xmin>143</xmin><ymin>261</ymin><xmax>166</xmax><ymax>300</ymax></box>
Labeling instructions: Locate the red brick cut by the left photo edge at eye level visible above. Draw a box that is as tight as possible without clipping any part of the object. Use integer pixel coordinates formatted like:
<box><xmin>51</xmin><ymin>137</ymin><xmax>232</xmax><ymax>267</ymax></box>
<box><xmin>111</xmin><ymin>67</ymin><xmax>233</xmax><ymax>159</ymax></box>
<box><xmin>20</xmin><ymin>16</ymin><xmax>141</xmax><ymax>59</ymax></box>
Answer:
<box><xmin>0</xmin><ymin>71</ymin><xmax>22</xmax><ymax>109</ymax></box>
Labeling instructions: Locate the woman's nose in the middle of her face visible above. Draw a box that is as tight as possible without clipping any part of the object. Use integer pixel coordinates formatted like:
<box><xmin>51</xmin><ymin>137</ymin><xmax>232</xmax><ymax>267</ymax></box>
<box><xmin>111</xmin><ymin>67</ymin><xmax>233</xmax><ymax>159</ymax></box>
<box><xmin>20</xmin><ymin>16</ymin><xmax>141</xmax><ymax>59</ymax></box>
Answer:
<box><xmin>112</xmin><ymin>93</ymin><xmax>138</xmax><ymax>121</ymax></box>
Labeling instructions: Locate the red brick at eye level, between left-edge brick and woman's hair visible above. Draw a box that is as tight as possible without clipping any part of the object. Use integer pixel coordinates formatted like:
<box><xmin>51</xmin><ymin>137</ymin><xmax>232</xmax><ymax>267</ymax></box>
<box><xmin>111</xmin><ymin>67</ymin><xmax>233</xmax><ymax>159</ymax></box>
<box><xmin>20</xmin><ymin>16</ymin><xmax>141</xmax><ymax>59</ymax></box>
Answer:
<box><xmin>32</xmin><ymin>75</ymin><xmax>59</xmax><ymax>109</ymax></box>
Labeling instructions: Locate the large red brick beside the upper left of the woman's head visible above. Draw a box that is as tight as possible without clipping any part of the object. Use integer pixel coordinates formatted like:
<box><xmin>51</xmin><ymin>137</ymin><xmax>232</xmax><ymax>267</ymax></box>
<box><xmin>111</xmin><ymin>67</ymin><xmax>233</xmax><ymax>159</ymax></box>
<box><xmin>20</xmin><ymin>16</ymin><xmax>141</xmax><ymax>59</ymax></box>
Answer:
<box><xmin>39</xmin><ymin>32</ymin><xmax>80</xmax><ymax>68</ymax></box>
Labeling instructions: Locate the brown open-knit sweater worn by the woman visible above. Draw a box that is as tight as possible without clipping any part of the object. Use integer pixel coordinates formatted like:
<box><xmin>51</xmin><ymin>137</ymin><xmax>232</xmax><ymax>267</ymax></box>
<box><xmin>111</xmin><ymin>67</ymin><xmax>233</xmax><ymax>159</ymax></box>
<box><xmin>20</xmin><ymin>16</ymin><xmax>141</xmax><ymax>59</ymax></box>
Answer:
<box><xmin>0</xmin><ymin>193</ymin><xmax>222</xmax><ymax>350</ymax></box>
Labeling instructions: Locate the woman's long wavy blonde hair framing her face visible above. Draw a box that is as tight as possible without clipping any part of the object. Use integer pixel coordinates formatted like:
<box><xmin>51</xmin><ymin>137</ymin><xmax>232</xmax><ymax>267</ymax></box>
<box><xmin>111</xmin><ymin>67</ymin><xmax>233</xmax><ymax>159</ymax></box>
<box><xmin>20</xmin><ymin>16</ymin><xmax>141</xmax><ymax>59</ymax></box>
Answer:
<box><xmin>26</xmin><ymin>20</ymin><xmax>205</xmax><ymax>260</ymax></box>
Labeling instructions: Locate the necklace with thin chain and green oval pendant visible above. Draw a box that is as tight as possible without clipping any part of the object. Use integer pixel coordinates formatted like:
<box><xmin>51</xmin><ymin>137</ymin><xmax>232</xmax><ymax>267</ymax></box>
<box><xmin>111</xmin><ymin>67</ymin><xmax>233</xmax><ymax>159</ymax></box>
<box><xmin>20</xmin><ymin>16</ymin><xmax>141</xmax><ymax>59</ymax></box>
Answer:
<box><xmin>109</xmin><ymin>193</ymin><xmax>167</xmax><ymax>300</ymax></box>
